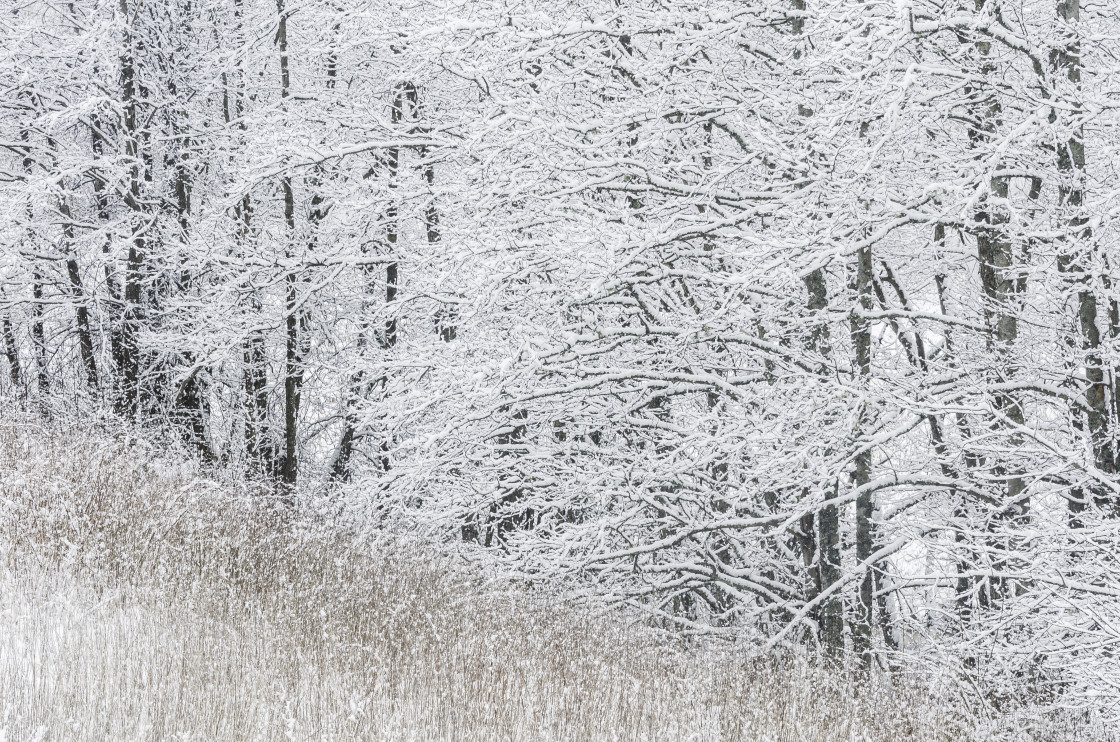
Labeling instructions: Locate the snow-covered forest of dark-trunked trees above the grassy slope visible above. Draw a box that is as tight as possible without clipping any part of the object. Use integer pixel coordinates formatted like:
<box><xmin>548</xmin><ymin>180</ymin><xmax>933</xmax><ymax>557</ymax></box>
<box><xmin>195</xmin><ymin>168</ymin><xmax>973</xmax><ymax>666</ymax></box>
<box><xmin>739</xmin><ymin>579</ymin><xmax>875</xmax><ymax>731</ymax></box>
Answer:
<box><xmin>0</xmin><ymin>0</ymin><xmax>1120</xmax><ymax>739</ymax></box>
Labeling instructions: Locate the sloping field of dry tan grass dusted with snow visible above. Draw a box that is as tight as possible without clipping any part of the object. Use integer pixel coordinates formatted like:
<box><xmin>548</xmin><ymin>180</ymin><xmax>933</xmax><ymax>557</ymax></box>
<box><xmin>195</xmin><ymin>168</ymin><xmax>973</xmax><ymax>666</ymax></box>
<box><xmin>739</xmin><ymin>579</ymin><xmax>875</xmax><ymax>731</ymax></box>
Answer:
<box><xmin>0</xmin><ymin>414</ymin><xmax>1086</xmax><ymax>742</ymax></box>
